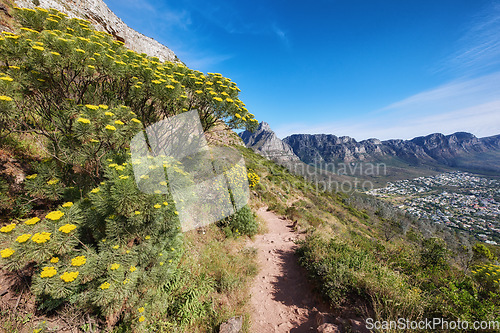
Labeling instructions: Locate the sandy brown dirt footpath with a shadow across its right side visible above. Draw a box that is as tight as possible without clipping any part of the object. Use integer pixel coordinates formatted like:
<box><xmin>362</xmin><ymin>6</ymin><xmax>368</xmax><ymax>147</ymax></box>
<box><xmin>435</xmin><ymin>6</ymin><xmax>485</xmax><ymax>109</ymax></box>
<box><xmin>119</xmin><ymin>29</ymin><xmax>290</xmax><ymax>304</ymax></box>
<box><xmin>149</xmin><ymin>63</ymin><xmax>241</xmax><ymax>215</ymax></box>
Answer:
<box><xmin>250</xmin><ymin>208</ymin><xmax>319</xmax><ymax>333</ymax></box>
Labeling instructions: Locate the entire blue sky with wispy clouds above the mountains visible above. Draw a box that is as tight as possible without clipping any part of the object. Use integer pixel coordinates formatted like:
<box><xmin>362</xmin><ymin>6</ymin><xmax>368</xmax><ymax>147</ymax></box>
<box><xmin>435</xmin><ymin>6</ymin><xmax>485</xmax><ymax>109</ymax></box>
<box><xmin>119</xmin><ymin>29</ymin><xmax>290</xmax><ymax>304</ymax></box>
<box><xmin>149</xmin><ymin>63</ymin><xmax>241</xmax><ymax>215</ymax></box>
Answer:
<box><xmin>104</xmin><ymin>0</ymin><xmax>500</xmax><ymax>140</ymax></box>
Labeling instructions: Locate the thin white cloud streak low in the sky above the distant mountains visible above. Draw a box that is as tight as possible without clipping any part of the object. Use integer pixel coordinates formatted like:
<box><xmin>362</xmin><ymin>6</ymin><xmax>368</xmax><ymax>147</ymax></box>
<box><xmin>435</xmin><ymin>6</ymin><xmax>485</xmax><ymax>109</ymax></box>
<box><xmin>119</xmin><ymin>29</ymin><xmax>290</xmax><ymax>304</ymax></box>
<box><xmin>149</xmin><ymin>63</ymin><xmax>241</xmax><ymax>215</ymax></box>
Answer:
<box><xmin>276</xmin><ymin>72</ymin><xmax>500</xmax><ymax>140</ymax></box>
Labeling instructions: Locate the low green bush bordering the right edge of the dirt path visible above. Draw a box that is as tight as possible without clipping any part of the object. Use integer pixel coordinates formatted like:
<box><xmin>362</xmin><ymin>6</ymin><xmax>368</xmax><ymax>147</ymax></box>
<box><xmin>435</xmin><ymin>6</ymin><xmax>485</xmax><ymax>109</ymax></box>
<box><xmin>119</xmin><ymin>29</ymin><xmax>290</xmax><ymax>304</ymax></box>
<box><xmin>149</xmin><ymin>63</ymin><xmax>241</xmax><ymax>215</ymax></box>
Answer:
<box><xmin>298</xmin><ymin>234</ymin><xmax>423</xmax><ymax>320</ymax></box>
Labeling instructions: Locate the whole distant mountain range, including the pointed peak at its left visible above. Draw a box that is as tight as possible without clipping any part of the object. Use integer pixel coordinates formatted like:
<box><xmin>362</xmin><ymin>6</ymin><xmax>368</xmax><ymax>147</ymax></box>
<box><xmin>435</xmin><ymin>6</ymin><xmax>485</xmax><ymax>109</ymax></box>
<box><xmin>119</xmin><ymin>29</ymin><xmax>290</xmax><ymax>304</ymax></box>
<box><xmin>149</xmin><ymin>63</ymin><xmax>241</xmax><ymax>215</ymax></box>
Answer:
<box><xmin>240</xmin><ymin>123</ymin><xmax>500</xmax><ymax>175</ymax></box>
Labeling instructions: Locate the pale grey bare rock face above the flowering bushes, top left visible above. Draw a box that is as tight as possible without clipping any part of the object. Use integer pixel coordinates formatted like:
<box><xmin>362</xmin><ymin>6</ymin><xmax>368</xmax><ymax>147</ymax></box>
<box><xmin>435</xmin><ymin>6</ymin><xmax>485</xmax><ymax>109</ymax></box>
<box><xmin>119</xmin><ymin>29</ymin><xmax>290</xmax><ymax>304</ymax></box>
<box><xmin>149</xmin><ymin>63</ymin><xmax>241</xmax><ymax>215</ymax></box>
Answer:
<box><xmin>15</xmin><ymin>0</ymin><xmax>179</xmax><ymax>61</ymax></box>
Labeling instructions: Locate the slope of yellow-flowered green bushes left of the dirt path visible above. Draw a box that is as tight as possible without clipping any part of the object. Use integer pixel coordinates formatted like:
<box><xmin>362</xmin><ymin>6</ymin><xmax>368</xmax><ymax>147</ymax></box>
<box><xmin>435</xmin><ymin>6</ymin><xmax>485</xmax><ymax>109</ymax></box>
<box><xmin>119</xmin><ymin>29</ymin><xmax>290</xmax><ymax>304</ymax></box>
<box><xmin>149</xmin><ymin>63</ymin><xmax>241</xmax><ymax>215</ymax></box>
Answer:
<box><xmin>0</xmin><ymin>8</ymin><xmax>258</xmax><ymax>332</ymax></box>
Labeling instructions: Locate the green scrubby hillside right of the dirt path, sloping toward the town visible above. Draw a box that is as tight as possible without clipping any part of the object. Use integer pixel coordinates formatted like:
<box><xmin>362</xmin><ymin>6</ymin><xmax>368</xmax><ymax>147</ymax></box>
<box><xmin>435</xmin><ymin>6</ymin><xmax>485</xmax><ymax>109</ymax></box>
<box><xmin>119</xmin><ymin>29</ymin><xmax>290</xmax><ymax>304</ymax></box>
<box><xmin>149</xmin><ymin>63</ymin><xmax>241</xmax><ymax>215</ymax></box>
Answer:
<box><xmin>237</xmin><ymin>145</ymin><xmax>500</xmax><ymax>322</ymax></box>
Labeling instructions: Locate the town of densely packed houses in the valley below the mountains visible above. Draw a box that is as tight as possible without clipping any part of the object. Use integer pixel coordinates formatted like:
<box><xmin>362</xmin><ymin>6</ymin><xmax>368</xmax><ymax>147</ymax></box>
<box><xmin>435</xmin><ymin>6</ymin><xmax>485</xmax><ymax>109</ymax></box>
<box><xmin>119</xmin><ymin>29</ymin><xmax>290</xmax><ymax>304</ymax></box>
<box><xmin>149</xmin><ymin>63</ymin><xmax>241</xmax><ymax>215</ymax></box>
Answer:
<box><xmin>367</xmin><ymin>171</ymin><xmax>500</xmax><ymax>245</ymax></box>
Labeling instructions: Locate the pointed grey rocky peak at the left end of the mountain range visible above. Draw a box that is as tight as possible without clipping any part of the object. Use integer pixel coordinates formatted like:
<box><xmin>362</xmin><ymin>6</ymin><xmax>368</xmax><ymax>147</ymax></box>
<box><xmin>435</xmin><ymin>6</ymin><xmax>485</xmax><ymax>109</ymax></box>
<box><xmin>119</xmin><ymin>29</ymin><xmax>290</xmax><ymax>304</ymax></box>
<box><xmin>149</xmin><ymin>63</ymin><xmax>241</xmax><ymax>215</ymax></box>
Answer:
<box><xmin>239</xmin><ymin>122</ymin><xmax>299</xmax><ymax>163</ymax></box>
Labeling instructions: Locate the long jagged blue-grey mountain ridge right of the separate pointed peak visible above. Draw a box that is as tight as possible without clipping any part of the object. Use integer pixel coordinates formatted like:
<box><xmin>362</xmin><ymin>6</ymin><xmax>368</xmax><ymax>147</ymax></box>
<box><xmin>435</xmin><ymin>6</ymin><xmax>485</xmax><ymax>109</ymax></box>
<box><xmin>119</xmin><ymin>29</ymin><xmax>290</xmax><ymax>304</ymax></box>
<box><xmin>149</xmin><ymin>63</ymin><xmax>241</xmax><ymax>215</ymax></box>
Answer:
<box><xmin>283</xmin><ymin>132</ymin><xmax>500</xmax><ymax>171</ymax></box>
